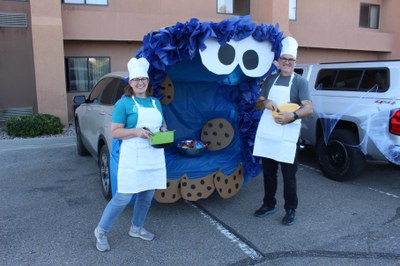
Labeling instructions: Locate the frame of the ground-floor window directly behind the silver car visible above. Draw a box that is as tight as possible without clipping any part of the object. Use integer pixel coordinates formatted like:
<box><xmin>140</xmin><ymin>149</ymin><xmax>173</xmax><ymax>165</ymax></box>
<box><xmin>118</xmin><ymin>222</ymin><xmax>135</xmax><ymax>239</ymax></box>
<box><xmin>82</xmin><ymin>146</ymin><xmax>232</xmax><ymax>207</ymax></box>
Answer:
<box><xmin>64</xmin><ymin>56</ymin><xmax>111</xmax><ymax>93</ymax></box>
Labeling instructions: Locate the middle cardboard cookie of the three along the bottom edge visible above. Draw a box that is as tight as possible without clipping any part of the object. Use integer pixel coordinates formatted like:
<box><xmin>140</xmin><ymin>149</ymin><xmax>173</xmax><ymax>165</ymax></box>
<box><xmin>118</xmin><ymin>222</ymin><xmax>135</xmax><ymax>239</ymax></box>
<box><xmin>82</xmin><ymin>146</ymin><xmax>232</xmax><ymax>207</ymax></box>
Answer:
<box><xmin>181</xmin><ymin>172</ymin><xmax>216</xmax><ymax>201</ymax></box>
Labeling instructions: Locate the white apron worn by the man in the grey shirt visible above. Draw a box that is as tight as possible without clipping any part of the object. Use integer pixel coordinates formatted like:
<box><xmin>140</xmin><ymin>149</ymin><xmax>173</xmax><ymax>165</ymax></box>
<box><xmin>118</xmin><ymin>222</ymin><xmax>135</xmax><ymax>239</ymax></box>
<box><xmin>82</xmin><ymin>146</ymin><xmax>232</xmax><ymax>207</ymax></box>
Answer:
<box><xmin>253</xmin><ymin>75</ymin><xmax>301</xmax><ymax>163</ymax></box>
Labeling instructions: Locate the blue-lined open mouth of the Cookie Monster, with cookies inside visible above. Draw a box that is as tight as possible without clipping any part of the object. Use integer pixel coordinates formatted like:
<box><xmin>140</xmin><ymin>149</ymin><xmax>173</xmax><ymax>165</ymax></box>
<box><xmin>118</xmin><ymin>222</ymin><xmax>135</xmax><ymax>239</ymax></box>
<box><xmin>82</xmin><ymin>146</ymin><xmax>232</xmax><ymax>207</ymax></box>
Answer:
<box><xmin>155</xmin><ymin>58</ymin><xmax>244</xmax><ymax>202</ymax></box>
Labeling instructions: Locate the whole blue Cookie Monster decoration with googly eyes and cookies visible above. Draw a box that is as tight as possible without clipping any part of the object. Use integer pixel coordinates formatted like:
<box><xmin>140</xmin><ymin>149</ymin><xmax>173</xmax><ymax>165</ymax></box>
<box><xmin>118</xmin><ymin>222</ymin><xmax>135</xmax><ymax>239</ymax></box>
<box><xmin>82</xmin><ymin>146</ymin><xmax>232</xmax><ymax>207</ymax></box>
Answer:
<box><xmin>111</xmin><ymin>16</ymin><xmax>283</xmax><ymax>203</ymax></box>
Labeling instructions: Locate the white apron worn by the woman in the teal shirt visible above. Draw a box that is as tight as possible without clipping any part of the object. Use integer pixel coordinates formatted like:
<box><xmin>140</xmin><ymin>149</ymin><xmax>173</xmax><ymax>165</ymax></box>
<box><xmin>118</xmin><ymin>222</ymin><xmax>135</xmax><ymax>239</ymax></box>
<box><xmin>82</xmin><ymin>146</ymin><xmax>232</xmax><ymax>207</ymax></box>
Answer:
<box><xmin>117</xmin><ymin>97</ymin><xmax>167</xmax><ymax>193</ymax></box>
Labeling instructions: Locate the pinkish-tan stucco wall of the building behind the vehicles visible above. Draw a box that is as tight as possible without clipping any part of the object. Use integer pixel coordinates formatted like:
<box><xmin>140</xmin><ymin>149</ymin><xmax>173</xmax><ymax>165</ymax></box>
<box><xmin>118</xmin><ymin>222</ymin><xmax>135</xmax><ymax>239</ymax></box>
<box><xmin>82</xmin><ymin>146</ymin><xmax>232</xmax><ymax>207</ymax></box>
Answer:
<box><xmin>0</xmin><ymin>0</ymin><xmax>400</xmax><ymax>124</ymax></box>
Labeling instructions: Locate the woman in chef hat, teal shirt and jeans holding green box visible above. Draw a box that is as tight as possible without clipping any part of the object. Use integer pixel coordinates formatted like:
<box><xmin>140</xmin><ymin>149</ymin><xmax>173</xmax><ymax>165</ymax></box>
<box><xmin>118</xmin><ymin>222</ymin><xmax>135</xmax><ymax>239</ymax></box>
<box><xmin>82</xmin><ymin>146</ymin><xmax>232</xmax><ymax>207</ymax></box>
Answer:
<box><xmin>94</xmin><ymin>58</ymin><xmax>167</xmax><ymax>251</ymax></box>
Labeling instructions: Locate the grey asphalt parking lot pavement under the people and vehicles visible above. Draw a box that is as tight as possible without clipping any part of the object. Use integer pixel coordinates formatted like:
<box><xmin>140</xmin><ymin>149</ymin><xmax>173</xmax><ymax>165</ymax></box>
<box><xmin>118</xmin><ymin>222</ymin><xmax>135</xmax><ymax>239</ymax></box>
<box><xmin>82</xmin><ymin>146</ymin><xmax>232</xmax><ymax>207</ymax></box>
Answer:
<box><xmin>0</xmin><ymin>137</ymin><xmax>400</xmax><ymax>266</ymax></box>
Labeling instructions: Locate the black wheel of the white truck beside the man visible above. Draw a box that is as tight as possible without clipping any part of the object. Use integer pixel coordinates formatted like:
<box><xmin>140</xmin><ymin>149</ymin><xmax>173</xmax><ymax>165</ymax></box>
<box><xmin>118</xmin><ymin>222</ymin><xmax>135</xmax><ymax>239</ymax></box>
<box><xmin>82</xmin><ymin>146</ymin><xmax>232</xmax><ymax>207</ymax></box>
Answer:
<box><xmin>317</xmin><ymin>129</ymin><xmax>365</xmax><ymax>181</ymax></box>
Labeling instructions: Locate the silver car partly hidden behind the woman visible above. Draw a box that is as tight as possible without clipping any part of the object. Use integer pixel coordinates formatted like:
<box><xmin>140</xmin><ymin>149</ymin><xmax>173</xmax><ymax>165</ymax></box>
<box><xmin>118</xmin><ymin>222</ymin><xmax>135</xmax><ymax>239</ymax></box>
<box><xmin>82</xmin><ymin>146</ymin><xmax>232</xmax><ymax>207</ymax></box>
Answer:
<box><xmin>73</xmin><ymin>72</ymin><xmax>128</xmax><ymax>200</ymax></box>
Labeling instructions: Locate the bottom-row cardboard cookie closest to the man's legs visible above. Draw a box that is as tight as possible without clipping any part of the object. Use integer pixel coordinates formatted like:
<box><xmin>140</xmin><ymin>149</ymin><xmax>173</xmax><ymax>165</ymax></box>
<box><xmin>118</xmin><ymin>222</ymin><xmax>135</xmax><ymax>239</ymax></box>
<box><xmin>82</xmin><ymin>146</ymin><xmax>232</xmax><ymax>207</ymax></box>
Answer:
<box><xmin>214</xmin><ymin>163</ymin><xmax>244</xmax><ymax>199</ymax></box>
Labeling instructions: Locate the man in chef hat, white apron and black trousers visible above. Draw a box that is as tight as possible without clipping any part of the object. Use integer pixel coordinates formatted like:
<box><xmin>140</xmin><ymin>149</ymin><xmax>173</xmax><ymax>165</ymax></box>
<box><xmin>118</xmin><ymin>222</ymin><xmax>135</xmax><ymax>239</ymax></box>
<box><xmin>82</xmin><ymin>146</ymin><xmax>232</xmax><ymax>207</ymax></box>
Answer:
<box><xmin>253</xmin><ymin>37</ymin><xmax>313</xmax><ymax>225</ymax></box>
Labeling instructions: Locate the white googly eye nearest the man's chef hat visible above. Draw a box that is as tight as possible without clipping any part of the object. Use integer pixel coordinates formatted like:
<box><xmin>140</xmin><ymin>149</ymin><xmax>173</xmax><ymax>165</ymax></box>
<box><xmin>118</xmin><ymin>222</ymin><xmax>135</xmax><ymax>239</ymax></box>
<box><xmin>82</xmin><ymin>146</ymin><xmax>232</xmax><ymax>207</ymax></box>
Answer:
<box><xmin>236</xmin><ymin>36</ymin><xmax>274</xmax><ymax>77</ymax></box>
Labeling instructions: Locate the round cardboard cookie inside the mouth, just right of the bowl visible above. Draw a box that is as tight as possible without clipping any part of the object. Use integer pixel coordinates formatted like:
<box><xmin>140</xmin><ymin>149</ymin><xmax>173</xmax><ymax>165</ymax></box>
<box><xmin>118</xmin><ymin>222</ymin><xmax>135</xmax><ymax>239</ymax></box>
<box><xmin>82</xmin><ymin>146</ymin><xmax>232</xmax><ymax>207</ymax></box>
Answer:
<box><xmin>201</xmin><ymin>118</ymin><xmax>235</xmax><ymax>151</ymax></box>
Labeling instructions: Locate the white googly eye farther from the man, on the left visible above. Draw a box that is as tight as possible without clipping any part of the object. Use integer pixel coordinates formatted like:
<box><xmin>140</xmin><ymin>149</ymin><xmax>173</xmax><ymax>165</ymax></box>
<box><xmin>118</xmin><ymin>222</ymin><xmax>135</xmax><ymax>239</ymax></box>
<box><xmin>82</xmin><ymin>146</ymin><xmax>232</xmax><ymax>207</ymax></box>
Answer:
<box><xmin>200</xmin><ymin>38</ymin><xmax>238</xmax><ymax>75</ymax></box>
